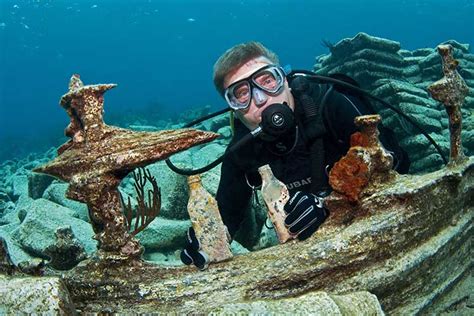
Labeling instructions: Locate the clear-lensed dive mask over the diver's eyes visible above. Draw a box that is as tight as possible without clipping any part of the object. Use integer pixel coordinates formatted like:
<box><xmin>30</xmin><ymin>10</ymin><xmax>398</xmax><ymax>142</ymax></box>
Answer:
<box><xmin>224</xmin><ymin>65</ymin><xmax>285</xmax><ymax>110</ymax></box>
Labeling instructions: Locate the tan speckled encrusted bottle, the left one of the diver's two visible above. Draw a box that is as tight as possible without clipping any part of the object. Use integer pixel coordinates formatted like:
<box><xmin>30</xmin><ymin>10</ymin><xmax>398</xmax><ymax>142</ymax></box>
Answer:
<box><xmin>188</xmin><ymin>175</ymin><xmax>232</xmax><ymax>262</ymax></box>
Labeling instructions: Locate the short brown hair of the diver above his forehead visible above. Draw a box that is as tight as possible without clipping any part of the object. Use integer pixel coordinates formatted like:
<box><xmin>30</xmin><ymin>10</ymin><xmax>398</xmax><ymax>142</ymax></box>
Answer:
<box><xmin>213</xmin><ymin>42</ymin><xmax>279</xmax><ymax>95</ymax></box>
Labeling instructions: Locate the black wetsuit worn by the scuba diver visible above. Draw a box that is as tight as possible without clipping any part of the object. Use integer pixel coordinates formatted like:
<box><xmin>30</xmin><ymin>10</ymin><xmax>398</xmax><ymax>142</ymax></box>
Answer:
<box><xmin>216</xmin><ymin>78</ymin><xmax>409</xmax><ymax>236</ymax></box>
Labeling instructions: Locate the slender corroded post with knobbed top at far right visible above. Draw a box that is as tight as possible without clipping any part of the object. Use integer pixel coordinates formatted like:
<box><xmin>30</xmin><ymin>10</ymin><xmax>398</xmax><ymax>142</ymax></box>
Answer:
<box><xmin>428</xmin><ymin>45</ymin><xmax>469</xmax><ymax>164</ymax></box>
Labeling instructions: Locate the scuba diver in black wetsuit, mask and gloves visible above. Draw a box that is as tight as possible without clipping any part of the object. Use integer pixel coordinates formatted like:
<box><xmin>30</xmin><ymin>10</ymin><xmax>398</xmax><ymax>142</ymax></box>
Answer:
<box><xmin>181</xmin><ymin>42</ymin><xmax>410</xmax><ymax>269</ymax></box>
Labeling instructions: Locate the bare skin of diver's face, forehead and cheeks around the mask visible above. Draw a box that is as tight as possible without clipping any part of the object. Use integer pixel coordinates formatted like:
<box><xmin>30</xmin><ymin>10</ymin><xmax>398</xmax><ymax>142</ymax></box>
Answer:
<box><xmin>224</xmin><ymin>57</ymin><xmax>295</xmax><ymax>130</ymax></box>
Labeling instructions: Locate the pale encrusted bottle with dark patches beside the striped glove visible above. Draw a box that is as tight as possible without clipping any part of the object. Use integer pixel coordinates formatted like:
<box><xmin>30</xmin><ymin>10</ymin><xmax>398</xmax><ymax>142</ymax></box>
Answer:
<box><xmin>258</xmin><ymin>165</ymin><xmax>295</xmax><ymax>243</ymax></box>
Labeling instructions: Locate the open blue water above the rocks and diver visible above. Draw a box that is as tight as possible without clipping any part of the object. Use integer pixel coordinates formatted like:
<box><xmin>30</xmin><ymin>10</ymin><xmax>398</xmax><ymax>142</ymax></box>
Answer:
<box><xmin>0</xmin><ymin>0</ymin><xmax>474</xmax><ymax>161</ymax></box>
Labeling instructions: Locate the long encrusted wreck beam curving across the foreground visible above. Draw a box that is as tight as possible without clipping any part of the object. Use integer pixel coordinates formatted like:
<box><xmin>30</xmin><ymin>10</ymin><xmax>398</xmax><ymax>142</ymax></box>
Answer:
<box><xmin>65</xmin><ymin>158</ymin><xmax>474</xmax><ymax>315</ymax></box>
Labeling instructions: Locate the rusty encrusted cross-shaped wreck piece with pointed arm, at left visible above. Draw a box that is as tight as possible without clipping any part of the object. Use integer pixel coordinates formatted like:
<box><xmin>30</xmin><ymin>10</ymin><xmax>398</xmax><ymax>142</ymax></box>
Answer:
<box><xmin>34</xmin><ymin>75</ymin><xmax>217</xmax><ymax>258</ymax></box>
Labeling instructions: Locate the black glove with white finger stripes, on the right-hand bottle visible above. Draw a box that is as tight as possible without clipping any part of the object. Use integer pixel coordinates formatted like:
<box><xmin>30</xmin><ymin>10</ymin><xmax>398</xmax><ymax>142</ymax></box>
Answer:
<box><xmin>284</xmin><ymin>191</ymin><xmax>329</xmax><ymax>240</ymax></box>
